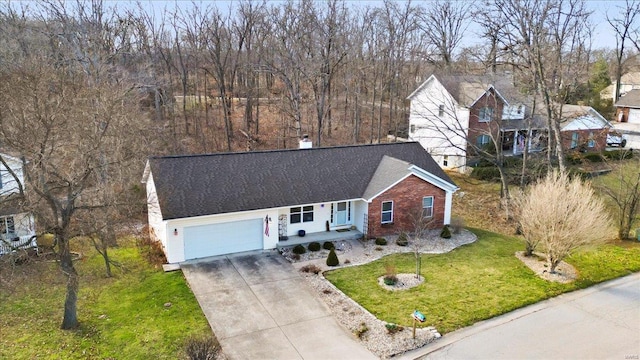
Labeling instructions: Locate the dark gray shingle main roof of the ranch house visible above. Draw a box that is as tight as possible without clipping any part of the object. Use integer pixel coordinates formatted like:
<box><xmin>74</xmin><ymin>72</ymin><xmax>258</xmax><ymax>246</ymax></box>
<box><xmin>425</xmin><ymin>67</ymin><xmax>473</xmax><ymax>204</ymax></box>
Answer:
<box><xmin>149</xmin><ymin>142</ymin><xmax>454</xmax><ymax>220</ymax></box>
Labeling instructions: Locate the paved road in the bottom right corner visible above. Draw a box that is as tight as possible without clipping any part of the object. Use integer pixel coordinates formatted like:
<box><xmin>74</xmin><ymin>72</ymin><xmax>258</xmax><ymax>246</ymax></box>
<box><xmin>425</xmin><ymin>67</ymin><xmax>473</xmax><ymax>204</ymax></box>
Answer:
<box><xmin>401</xmin><ymin>273</ymin><xmax>640</xmax><ymax>360</ymax></box>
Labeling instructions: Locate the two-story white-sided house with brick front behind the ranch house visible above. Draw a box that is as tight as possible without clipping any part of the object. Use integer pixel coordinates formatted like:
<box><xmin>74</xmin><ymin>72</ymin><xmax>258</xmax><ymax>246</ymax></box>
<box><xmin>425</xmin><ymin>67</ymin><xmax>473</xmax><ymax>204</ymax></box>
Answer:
<box><xmin>408</xmin><ymin>74</ymin><xmax>546</xmax><ymax>172</ymax></box>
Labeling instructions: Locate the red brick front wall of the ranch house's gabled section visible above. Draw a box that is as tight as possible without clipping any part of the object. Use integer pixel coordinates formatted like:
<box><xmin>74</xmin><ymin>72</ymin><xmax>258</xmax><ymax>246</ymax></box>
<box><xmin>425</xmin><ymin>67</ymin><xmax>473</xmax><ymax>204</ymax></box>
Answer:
<box><xmin>368</xmin><ymin>175</ymin><xmax>446</xmax><ymax>237</ymax></box>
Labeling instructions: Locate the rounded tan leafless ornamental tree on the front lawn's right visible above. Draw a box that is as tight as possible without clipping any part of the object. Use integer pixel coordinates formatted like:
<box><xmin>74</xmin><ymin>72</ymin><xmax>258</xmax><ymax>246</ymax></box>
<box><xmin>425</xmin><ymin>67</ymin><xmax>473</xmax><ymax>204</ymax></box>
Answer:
<box><xmin>519</xmin><ymin>171</ymin><xmax>609</xmax><ymax>273</ymax></box>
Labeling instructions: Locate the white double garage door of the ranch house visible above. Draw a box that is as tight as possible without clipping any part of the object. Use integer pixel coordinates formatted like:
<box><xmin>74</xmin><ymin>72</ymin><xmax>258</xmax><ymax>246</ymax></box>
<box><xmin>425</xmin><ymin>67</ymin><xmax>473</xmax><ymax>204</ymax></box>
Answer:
<box><xmin>184</xmin><ymin>219</ymin><xmax>263</xmax><ymax>260</ymax></box>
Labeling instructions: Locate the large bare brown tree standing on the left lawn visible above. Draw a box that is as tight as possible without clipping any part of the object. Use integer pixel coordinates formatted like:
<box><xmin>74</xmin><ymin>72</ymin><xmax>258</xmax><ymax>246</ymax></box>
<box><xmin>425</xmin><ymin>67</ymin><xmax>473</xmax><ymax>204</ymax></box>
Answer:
<box><xmin>0</xmin><ymin>3</ymin><xmax>144</xmax><ymax>329</ymax></box>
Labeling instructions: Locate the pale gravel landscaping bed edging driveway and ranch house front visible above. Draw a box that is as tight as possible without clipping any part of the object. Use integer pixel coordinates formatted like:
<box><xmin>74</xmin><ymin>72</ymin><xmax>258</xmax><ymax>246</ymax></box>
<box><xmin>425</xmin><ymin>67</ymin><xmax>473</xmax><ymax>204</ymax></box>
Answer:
<box><xmin>281</xmin><ymin>230</ymin><xmax>477</xmax><ymax>359</ymax></box>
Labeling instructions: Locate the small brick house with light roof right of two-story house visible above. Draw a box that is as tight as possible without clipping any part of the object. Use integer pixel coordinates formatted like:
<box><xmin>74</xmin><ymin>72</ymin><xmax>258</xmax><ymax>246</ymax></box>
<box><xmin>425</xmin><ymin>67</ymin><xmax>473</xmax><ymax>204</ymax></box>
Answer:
<box><xmin>560</xmin><ymin>105</ymin><xmax>613</xmax><ymax>152</ymax></box>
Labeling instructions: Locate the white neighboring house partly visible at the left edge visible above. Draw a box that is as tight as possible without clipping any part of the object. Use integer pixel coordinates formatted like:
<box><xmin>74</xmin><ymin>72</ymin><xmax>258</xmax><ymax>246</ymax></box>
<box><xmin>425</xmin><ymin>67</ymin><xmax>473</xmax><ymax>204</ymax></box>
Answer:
<box><xmin>0</xmin><ymin>154</ymin><xmax>36</xmax><ymax>255</ymax></box>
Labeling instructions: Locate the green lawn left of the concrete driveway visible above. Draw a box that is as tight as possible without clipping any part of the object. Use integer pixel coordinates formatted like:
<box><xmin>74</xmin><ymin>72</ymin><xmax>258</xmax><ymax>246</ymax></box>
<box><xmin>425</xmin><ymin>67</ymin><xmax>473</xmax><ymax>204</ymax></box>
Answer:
<box><xmin>0</xmin><ymin>239</ymin><xmax>211</xmax><ymax>359</ymax></box>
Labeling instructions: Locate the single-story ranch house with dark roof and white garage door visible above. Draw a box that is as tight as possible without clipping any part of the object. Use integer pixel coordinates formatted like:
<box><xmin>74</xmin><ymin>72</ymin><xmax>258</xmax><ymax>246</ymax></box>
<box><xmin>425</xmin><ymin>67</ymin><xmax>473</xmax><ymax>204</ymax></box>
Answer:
<box><xmin>143</xmin><ymin>142</ymin><xmax>458</xmax><ymax>263</ymax></box>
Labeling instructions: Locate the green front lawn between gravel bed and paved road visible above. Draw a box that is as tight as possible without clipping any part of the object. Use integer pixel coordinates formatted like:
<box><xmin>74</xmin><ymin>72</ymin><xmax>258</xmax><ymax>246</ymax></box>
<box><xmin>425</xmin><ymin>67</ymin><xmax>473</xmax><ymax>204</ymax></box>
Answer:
<box><xmin>325</xmin><ymin>229</ymin><xmax>640</xmax><ymax>333</ymax></box>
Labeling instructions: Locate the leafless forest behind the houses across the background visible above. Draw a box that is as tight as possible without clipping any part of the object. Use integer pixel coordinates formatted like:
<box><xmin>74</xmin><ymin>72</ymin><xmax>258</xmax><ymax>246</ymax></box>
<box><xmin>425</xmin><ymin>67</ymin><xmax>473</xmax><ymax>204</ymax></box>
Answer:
<box><xmin>0</xmin><ymin>0</ymin><xmax>638</xmax><ymax>158</ymax></box>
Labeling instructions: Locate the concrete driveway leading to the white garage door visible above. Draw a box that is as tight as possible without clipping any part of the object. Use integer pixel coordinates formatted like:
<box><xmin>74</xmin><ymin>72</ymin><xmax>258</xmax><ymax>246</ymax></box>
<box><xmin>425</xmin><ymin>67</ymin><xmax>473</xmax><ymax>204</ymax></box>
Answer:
<box><xmin>180</xmin><ymin>253</ymin><xmax>376</xmax><ymax>359</ymax></box>
